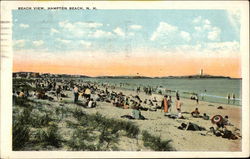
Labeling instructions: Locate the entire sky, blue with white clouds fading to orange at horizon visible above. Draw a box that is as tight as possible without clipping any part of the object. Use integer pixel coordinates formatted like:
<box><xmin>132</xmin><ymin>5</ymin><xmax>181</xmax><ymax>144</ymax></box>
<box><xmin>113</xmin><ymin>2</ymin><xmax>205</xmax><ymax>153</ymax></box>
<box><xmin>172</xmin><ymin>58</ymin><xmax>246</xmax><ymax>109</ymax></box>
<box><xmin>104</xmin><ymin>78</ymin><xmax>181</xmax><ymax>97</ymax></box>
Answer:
<box><xmin>12</xmin><ymin>10</ymin><xmax>241</xmax><ymax>77</ymax></box>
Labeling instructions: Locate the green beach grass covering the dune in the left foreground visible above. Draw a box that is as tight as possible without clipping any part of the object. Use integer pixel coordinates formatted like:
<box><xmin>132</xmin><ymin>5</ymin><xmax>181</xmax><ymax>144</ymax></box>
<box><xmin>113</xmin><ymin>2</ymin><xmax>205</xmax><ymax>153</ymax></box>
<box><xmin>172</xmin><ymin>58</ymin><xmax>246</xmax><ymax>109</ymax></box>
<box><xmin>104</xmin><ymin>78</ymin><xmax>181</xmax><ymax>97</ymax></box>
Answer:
<box><xmin>13</xmin><ymin>95</ymin><xmax>174</xmax><ymax>151</ymax></box>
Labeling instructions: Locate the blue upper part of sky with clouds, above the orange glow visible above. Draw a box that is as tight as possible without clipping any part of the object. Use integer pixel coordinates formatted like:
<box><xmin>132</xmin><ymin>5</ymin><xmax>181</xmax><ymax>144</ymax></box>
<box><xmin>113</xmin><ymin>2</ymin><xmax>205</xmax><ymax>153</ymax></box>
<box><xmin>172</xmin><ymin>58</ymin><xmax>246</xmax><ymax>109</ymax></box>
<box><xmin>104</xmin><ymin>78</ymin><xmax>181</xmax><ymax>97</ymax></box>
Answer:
<box><xmin>13</xmin><ymin>10</ymin><xmax>240</xmax><ymax>53</ymax></box>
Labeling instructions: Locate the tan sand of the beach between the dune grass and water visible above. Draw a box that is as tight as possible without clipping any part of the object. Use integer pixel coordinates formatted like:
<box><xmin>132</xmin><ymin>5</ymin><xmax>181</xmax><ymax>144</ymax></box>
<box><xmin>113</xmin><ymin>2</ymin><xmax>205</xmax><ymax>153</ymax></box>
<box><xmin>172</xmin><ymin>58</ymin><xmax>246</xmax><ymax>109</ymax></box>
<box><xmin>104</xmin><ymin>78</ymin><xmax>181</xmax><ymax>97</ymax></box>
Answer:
<box><xmin>18</xmin><ymin>83</ymin><xmax>241</xmax><ymax>151</ymax></box>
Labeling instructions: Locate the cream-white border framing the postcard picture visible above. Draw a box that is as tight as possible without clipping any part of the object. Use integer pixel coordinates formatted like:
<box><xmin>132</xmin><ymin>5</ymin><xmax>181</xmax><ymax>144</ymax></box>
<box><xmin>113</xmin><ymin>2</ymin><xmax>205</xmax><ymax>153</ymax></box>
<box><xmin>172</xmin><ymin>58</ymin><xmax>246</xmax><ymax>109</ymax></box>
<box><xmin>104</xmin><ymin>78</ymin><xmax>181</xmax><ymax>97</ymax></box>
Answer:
<box><xmin>0</xmin><ymin>1</ymin><xmax>249</xmax><ymax>158</ymax></box>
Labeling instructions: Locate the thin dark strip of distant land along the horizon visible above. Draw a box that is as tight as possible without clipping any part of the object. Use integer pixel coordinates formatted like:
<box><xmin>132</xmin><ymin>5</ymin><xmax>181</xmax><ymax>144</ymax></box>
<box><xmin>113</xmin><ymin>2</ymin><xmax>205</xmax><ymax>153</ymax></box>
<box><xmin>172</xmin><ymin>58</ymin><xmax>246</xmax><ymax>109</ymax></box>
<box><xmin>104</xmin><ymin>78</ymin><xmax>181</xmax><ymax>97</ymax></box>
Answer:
<box><xmin>12</xmin><ymin>72</ymin><xmax>241</xmax><ymax>79</ymax></box>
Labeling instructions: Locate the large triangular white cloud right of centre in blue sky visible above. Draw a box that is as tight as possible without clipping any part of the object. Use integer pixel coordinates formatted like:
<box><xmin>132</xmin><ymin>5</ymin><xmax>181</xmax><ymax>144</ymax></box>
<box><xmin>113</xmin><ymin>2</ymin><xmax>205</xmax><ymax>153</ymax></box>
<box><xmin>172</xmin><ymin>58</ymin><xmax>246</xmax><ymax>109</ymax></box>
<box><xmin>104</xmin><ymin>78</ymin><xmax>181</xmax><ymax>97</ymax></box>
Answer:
<box><xmin>150</xmin><ymin>22</ymin><xmax>178</xmax><ymax>41</ymax></box>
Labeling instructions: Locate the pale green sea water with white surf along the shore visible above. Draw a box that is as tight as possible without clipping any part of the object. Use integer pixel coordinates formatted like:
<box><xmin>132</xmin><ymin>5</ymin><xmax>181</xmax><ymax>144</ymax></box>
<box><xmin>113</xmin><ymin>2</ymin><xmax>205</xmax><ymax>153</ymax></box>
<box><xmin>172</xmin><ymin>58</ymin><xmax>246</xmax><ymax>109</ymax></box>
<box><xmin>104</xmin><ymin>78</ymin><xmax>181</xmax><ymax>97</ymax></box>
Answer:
<box><xmin>79</xmin><ymin>78</ymin><xmax>242</xmax><ymax>105</ymax></box>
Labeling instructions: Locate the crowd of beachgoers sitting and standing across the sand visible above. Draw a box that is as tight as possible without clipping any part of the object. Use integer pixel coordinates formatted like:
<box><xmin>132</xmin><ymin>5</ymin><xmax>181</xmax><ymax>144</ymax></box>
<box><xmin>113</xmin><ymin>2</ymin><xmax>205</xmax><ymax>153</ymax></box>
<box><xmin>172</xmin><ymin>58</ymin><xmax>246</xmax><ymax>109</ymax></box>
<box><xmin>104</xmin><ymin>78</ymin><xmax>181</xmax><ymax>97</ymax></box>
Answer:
<box><xmin>13</xmin><ymin>78</ymin><xmax>240</xmax><ymax>139</ymax></box>
